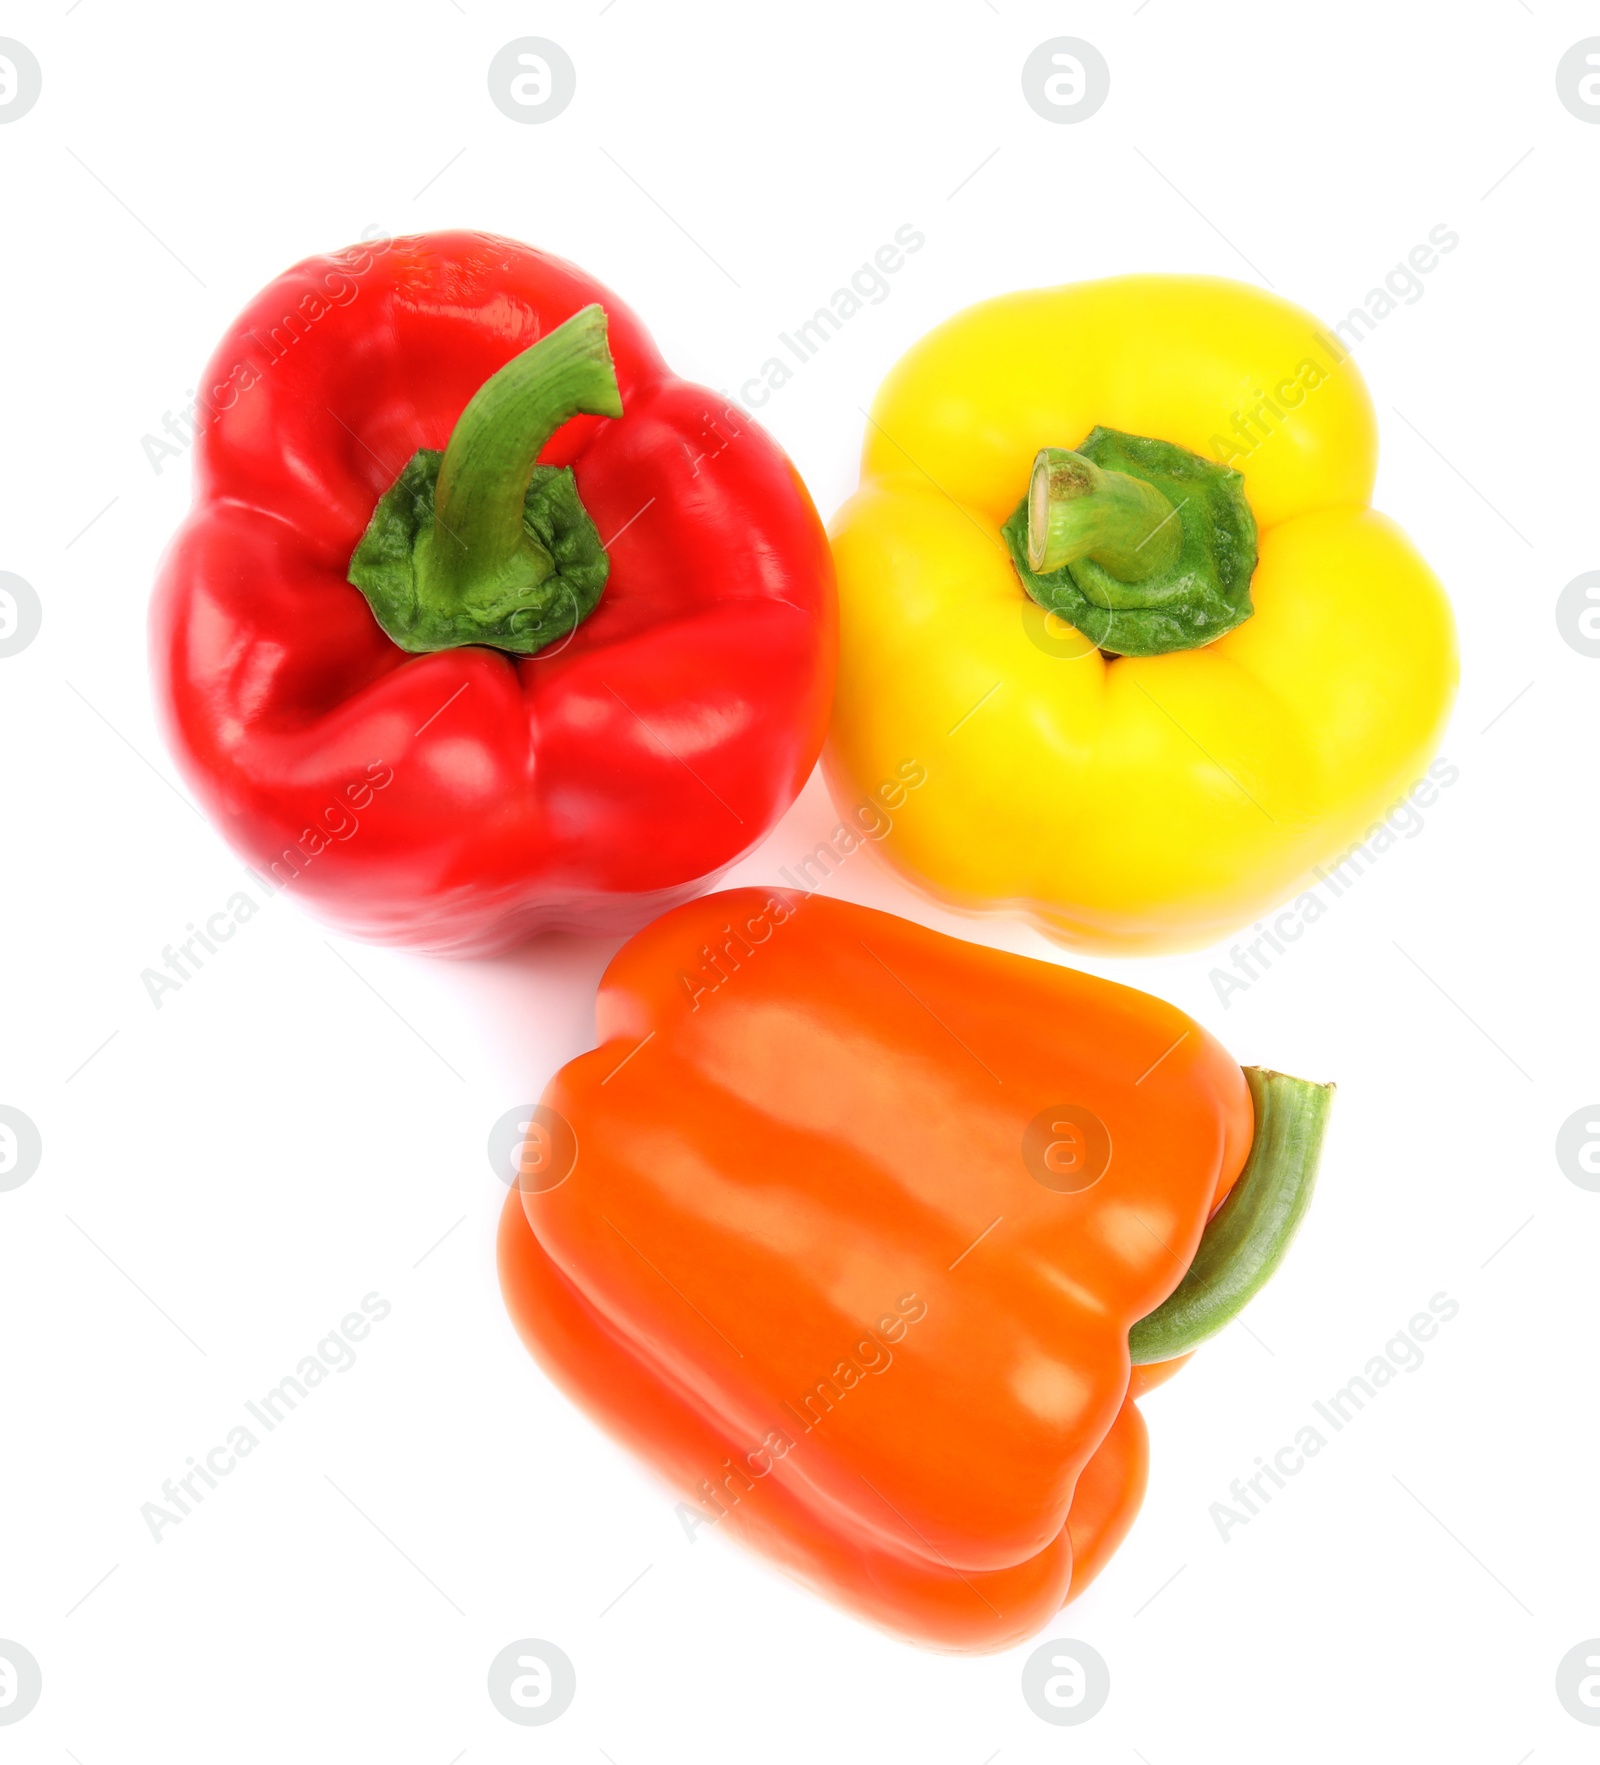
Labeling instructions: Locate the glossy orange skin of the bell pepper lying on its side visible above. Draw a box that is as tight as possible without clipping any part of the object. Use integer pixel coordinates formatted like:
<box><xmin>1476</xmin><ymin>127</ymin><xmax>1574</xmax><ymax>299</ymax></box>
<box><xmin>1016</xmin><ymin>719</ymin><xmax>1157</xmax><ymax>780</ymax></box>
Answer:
<box><xmin>499</xmin><ymin>890</ymin><xmax>1295</xmax><ymax>1650</ymax></box>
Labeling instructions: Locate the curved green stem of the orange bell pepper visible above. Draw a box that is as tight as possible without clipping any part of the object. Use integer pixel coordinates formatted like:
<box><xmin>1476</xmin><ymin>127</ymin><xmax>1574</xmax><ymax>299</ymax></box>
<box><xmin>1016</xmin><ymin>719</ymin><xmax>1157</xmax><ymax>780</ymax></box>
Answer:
<box><xmin>1127</xmin><ymin>1066</ymin><xmax>1334</xmax><ymax>1366</ymax></box>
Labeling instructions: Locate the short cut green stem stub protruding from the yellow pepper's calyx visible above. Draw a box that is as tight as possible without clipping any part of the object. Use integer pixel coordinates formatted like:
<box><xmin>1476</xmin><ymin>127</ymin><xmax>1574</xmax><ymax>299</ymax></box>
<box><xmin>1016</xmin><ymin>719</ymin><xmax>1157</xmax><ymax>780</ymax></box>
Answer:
<box><xmin>1028</xmin><ymin>447</ymin><xmax>1184</xmax><ymax>582</ymax></box>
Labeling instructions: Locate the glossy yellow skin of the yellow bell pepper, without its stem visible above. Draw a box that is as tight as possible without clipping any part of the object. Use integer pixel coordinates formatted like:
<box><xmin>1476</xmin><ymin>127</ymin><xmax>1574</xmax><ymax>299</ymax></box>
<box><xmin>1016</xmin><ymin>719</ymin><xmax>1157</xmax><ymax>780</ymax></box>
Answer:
<box><xmin>826</xmin><ymin>275</ymin><xmax>1457</xmax><ymax>951</ymax></box>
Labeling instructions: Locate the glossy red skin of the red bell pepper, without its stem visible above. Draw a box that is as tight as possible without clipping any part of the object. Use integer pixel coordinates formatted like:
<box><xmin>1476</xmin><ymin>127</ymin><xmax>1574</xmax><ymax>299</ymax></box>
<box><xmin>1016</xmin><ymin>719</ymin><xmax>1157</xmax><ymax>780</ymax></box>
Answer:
<box><xmin>152</xmin><ymin>233</ymin><xmax>836</xmax><ymax>955</ymax></box>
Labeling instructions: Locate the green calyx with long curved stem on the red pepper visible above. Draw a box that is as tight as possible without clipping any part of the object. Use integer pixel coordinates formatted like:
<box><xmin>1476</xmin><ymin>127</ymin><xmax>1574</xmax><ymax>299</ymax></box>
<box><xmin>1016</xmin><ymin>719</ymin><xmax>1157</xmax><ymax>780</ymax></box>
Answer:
<box><xmin>349</xmin><ymin>305</ymin><xmax>623</xmax><ymax>655</ymax></box>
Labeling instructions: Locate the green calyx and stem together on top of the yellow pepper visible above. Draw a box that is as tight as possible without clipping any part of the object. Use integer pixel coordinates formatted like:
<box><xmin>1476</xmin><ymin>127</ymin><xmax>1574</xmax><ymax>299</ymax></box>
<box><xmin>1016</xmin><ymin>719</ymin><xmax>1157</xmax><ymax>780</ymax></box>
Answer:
<box><xmin>1000</xmin><ymin>429</ymin><xmax>1256</xmax><ymax>657</ymax></box>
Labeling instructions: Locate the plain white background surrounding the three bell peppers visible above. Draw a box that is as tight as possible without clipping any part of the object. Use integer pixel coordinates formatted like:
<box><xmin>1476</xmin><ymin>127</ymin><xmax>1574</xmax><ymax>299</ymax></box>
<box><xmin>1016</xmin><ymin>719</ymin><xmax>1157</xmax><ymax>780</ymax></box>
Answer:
<box><xmin>0</xmin><ymin>0</ymin><xmax>1600</xmax><ymax>1765</ymax></box>
